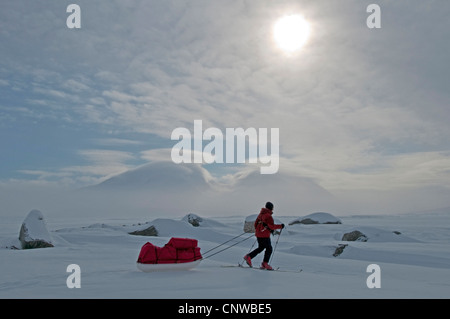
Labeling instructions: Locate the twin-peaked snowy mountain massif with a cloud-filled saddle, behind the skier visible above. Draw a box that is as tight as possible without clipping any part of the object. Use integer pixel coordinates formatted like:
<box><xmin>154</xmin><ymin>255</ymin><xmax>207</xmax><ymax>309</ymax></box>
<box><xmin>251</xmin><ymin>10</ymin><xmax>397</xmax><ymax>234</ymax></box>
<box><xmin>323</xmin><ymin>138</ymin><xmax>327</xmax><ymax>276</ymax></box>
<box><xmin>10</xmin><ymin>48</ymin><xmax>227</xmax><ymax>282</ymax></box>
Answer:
<box><xmin>81</xmin><ymin>162</ymin><xmax>334</xmax><ymax>219</ymax></box>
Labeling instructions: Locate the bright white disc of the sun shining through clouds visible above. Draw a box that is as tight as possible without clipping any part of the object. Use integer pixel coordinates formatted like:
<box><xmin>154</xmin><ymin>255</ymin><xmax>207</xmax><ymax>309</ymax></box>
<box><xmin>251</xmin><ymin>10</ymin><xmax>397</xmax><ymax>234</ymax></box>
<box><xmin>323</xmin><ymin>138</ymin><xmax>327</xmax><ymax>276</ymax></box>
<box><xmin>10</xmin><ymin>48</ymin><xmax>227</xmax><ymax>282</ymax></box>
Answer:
<box><xmin>273</xmin><ymin>15</ymin><xmax>310</xmax><ymax>52</ymax></box>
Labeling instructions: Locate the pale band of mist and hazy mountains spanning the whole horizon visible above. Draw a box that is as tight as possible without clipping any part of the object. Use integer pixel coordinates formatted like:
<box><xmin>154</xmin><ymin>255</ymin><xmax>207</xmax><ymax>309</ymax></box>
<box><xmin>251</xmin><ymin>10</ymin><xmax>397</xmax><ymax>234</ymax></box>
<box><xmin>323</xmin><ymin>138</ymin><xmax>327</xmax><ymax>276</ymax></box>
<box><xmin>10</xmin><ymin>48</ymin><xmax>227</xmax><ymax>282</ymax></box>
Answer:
<box><xmin>0</xmin><ymin>161</ymin><xmax>448</xmax><ymax>221</ymax></box>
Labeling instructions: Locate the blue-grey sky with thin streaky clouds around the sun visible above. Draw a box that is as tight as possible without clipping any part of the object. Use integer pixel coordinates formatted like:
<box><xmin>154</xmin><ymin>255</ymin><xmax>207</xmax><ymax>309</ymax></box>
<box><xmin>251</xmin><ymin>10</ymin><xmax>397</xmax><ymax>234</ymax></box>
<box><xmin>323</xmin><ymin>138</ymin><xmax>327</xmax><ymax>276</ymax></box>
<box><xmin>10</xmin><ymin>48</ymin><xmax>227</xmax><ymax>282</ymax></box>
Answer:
<box><xmin>0</xmin><ymin>0</ymin><xmax>450</xmax><ymax>215</ymax></box>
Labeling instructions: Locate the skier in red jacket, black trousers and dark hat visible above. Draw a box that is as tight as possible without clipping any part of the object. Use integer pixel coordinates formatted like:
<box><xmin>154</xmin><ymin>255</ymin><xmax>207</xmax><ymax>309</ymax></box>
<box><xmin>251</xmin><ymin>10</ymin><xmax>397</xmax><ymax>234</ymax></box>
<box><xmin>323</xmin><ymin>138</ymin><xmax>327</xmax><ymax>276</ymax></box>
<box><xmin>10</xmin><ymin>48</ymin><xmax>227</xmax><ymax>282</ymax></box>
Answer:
<box><xmin>244</xmin><ymin>202</ymin><xmax>284</xmax><ymax>270</ymax></box>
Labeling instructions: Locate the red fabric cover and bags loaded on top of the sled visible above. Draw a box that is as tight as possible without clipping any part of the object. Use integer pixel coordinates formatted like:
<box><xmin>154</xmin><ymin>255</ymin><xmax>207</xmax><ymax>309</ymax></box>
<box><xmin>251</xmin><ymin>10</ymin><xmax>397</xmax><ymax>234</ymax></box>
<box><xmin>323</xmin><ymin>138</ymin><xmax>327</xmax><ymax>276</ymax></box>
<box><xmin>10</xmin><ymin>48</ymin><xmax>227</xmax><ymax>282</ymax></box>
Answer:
<box><xmin>137</xmin><ymin>238</ymin><xmax>202</xmax><ymax>264</ymax></box>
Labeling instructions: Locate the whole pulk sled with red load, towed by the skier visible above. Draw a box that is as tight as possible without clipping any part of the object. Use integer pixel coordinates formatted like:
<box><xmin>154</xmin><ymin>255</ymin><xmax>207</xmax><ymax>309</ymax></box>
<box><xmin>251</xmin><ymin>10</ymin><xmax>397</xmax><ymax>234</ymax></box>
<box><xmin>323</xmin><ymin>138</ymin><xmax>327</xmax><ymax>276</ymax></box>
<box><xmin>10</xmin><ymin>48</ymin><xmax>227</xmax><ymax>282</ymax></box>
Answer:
<box><xmin>137</xmin><ymin>237</ymin><xmax>202</xmax><ymax>272</ymax></box>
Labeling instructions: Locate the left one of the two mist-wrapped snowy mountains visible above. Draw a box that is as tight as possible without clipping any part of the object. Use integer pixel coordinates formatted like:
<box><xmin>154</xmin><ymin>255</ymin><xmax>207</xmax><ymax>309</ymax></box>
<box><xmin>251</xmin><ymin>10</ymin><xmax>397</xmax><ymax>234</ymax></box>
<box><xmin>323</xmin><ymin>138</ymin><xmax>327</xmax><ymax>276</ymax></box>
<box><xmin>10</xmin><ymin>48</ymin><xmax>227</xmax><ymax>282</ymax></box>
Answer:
<box><xmin>77</xmin><ymin>162</ymin><xmax>220</xmax><ymax>218</ymax></box>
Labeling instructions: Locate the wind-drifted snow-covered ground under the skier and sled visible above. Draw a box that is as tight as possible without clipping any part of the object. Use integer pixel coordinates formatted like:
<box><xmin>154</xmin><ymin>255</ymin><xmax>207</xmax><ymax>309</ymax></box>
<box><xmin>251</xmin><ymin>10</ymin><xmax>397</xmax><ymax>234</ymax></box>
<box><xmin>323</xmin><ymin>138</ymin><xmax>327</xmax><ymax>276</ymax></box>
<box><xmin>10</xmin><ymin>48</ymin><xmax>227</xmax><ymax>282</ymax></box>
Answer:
<box><xmin>0</xmin><ymin>210</ymin><xmax>450</xmax><ymax>300</ymax></box>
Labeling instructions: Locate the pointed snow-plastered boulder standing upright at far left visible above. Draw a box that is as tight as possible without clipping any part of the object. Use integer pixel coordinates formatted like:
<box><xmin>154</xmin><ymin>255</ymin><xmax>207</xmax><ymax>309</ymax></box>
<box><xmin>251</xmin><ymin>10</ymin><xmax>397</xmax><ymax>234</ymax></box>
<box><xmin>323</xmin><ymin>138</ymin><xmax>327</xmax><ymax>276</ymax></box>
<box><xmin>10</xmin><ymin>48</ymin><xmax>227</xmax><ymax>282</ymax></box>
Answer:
<box><xmin>19</xmin><ymin>209</ymin><xmax>54</xmax><ymax>249</ymax></box>
